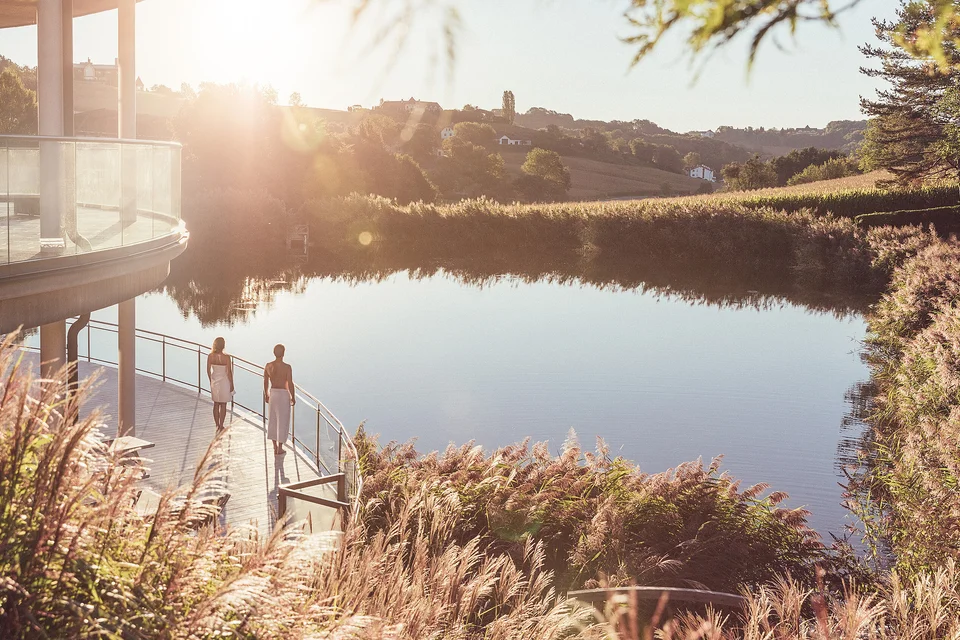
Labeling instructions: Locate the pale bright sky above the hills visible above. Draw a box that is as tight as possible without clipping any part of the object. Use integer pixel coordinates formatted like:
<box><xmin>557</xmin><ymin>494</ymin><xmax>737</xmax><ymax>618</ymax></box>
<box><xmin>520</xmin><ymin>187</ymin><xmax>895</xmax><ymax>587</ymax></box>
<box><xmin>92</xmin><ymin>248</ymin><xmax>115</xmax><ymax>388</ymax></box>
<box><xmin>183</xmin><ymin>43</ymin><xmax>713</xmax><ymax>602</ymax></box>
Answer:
<box><xmin>0</xmin><ymin>0</ymin><xmax>898</xmax><ymax>131</ymax></box>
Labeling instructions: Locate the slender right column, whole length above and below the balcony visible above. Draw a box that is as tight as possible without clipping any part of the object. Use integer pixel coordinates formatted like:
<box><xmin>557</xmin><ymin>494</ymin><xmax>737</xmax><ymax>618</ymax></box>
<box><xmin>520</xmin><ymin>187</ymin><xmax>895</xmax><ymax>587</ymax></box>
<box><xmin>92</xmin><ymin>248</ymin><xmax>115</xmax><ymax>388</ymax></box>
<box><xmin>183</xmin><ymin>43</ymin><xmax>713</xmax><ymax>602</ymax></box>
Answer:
<box><xmin>117</xmin><ymin>0</ymin><xmax>137</xmax><ymax>436</ymax></box>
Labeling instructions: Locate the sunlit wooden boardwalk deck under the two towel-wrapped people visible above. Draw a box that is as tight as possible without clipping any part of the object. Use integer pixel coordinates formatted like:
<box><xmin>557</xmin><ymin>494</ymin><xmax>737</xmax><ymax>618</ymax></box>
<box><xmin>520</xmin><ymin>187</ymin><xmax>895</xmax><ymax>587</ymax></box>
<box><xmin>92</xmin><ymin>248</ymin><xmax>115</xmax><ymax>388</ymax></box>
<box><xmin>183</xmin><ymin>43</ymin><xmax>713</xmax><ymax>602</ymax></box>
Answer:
<box><xmin>19</xmin><ymin>353</ymin><xmax>339</xmax><ymax>533</ymax></box>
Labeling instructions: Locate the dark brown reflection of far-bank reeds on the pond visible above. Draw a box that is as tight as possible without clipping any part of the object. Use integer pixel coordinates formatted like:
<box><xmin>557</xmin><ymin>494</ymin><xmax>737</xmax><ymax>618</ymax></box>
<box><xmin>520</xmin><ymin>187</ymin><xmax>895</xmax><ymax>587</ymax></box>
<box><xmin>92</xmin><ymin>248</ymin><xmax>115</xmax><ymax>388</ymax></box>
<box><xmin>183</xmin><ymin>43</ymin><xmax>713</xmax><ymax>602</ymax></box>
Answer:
<box><xmin>165</xmin><ymin>252</ymin><xmax>875</xmax><ymax>325</ymax></box>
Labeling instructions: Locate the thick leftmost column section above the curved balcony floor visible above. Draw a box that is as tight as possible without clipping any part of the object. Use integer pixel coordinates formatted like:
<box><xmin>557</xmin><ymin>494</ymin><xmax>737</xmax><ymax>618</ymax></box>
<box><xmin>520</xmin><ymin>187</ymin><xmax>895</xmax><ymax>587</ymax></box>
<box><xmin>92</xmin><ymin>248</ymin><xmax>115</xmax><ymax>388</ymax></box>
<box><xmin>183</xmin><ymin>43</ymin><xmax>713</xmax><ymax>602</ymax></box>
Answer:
<box><xmin>37</xmin><ymin>0</ymin><xmax>66</xmax><ymax>252</ymax></box>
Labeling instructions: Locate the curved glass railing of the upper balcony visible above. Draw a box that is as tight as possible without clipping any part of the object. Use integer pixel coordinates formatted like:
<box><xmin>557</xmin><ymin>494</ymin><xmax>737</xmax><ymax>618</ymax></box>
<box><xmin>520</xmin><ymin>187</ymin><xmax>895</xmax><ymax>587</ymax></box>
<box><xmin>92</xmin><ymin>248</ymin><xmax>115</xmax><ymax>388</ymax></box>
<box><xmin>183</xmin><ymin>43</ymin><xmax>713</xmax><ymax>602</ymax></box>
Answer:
<box><xmin>0</xmin><ymin>136</ymin><xmax>182</xmax><ymax>265</ymax></box>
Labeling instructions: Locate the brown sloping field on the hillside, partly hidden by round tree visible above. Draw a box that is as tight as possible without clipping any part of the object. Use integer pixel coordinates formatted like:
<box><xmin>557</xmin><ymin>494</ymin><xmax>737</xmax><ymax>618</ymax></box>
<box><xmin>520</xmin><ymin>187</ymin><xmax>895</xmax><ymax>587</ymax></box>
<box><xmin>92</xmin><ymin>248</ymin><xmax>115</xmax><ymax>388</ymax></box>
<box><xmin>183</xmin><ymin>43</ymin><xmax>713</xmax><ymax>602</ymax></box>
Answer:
<box><xmin>500</xmin><ymin>150</ymin><xmax>703</xmax><ymax>200</ymax></box>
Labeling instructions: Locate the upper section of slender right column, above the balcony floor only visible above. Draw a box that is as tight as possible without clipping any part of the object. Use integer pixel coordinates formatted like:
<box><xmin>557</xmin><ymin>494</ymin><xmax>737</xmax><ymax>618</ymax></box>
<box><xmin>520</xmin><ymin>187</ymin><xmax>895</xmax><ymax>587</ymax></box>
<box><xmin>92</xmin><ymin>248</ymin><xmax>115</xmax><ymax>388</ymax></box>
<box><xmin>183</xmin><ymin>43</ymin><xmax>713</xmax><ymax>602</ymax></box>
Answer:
<box><xmin>117</xmin><ymin>0</ymin><xmax>137</xmax><ymax>224</ymax></box>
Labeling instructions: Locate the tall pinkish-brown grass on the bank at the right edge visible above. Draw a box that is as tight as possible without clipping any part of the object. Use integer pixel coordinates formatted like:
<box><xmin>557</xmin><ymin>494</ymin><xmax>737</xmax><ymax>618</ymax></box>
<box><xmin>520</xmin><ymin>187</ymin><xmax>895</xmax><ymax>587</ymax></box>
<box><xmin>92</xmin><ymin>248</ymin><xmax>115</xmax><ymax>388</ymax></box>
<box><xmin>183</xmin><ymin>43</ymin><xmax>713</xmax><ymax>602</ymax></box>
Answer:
<box><xmin>859</xmin><ymin>241</ymin><xmax>960</xmax><ymax>575</ymax></box>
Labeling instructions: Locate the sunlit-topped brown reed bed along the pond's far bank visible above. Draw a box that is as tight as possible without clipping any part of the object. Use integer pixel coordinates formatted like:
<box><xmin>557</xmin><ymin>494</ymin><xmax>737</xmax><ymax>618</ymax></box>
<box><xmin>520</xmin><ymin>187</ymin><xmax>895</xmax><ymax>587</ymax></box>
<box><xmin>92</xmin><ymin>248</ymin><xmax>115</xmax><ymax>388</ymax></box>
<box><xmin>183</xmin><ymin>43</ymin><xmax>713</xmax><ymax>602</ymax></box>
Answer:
<box><xmin>300</xmin><ymin>195</ymin><xmax>889</xmax><ymax>295</ymax></box>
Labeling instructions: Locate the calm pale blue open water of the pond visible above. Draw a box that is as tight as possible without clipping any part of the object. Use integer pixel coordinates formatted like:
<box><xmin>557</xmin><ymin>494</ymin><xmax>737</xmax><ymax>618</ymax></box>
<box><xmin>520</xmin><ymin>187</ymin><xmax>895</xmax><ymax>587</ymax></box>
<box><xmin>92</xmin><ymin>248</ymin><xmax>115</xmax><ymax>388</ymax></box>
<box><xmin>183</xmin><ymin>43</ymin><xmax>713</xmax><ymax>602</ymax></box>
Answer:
<box><xmin>95</xmin><ymin>275</ymin><xmax>869</xmax><ymax>535</ymax></box>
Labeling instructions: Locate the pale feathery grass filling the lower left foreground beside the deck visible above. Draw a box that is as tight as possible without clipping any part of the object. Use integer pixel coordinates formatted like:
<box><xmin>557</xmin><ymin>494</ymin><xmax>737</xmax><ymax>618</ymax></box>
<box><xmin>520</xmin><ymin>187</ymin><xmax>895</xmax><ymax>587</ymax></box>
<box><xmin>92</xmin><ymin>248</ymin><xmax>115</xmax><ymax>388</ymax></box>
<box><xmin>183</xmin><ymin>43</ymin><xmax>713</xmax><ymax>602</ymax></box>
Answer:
<box><xmin>0</xmin><ymin>343</ymin><xmax>598</xmax><ymax>640</ymax></box>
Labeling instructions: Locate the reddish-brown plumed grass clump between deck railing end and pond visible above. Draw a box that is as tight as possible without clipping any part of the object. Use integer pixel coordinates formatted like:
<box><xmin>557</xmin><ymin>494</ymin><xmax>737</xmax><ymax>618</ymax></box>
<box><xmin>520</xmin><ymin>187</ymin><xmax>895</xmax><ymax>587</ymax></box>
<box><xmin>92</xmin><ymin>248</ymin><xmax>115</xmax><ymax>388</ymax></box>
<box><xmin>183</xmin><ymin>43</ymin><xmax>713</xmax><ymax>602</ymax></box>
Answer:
<box><xmin>358</xmin><ymin>428</ymin><xmax>827</xmax><ymax>591</ymax></box>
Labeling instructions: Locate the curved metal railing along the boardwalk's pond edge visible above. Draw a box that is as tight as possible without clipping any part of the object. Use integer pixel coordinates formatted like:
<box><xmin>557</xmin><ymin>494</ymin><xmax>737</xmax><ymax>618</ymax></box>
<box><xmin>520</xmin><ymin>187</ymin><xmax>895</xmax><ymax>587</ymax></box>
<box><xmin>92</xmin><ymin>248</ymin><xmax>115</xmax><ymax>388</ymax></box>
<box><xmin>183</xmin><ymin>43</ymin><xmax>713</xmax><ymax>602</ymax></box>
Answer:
<box><xmin>26</xmin><ymin>319</ymin><xmax>363</xmax><ymax>514</ymax></box>
